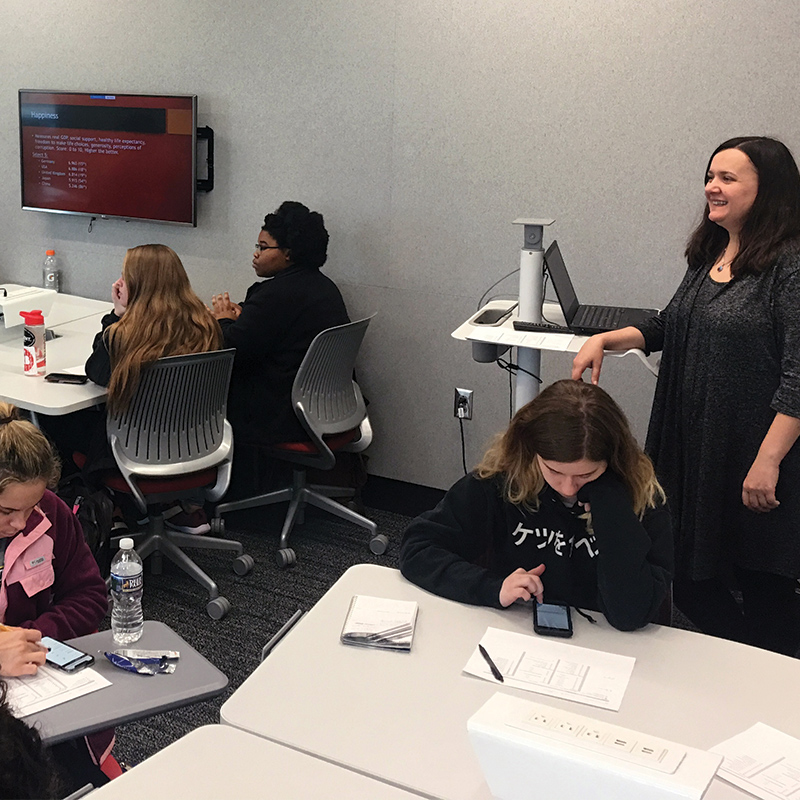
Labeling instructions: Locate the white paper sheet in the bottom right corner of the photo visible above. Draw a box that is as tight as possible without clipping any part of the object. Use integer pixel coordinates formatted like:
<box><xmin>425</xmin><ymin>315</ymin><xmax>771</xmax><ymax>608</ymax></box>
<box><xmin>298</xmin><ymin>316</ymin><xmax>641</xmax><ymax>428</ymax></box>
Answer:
<box><xmin>711</xmin><ymin>722</ymin><xmax>800</xmax><ymax>800</ymax></box>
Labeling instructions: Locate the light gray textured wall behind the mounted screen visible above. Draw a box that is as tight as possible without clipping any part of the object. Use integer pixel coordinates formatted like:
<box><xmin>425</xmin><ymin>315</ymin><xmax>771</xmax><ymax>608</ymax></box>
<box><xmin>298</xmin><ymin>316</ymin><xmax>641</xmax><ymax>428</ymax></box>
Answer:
<box><xmin>0</xmin><ymin>0</ymin><xmax>800</xmax><ymax>487</ymax></box>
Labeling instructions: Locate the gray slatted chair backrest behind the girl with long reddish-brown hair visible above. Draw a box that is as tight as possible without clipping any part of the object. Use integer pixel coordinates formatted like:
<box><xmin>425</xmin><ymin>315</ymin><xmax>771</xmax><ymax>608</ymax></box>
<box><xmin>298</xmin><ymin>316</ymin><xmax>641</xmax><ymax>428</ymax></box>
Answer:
<box><xmin>106</xmin><ymin>349</ymin><xmax>236</xmax><ymax>465</ymax></box>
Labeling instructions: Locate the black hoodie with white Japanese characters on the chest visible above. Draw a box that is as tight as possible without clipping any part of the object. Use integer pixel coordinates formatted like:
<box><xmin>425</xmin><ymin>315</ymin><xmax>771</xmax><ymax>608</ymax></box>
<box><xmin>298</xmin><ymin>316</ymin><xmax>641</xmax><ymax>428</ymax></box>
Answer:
<box><xmin>400</xmin><ymin>472</ymin><xmax>672</xmax><ymax>630</ymax></box>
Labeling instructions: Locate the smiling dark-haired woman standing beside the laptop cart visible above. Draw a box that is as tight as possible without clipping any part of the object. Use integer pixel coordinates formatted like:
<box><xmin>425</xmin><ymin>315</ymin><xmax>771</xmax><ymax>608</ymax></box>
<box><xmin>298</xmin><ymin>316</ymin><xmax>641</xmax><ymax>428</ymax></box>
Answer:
<box><xmin>573</xmin><ymin>136</ymin><xmax>800</xmax><ymax>655</ymax></box>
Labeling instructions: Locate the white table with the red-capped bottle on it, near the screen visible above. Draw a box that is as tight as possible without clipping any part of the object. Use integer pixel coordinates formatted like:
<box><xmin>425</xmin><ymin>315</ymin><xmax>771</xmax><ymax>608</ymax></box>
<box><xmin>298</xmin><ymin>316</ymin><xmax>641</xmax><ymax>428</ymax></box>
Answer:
<box><xmin>0</xmin><ymin>294</ymin><xmax>112</xmax><ymax>415</ymax></box>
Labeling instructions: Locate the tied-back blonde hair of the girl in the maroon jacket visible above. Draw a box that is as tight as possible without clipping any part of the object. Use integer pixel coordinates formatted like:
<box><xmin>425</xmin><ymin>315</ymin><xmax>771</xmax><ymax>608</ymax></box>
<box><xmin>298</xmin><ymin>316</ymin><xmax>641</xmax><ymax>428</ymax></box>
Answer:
<box><xmin>0</xmin><ymin>401</ymin><xmax>61</xmax><ymax>492</ymax></box>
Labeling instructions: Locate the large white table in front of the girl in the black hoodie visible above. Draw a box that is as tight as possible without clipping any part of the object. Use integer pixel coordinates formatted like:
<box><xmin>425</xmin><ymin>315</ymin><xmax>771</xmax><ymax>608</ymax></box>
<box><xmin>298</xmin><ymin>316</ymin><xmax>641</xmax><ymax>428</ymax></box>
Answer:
<box><xmin>221</xmin><ymin>565</ymin><xmax>800</xmax><ymax>800</ymax></box>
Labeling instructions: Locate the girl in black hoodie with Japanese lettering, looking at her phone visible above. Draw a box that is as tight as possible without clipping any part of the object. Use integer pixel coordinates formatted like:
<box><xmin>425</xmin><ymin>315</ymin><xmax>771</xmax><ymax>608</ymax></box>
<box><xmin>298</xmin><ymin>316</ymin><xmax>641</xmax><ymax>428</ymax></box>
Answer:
<box><xmin>400</xmin><ymin>380</ymin><xmax>673</xmax><ymax>630</ymax></box>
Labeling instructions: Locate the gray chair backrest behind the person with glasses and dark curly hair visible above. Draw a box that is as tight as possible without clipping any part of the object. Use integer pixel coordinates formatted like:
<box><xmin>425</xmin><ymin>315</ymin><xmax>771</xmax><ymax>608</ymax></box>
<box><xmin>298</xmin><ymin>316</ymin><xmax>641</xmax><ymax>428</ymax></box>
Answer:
<box><xmin>292</xmin><ymin>315</ymin><xmax>374</xmax><ymax>436</ymax></box>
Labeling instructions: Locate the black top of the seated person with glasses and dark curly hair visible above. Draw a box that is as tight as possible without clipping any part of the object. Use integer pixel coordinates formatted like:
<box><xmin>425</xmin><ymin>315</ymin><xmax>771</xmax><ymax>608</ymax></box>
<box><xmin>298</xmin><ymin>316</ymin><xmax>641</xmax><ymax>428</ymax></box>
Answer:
<box><xmin>220</xmin><ymin>266</ymin><xmax>350</xmax><ymax>444</ymax></box>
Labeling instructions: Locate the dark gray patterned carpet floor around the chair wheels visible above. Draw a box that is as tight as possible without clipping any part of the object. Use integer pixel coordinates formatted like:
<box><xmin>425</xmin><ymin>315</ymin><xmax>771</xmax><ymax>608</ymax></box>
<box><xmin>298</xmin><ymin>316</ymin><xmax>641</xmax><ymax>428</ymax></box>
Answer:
<box><xmin>102</xmin><ymin>503</ymin><xmax>409</xmax><ymax>764</ymax></box>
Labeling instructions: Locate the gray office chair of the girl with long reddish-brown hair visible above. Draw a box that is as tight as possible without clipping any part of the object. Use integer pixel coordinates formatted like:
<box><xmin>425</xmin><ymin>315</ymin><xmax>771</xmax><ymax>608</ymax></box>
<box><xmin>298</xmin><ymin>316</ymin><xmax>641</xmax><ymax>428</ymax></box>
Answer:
<box><xmin>98</xmin><ymin>350</ymin><xmax>253</xmax><ymax>619</ymax></box>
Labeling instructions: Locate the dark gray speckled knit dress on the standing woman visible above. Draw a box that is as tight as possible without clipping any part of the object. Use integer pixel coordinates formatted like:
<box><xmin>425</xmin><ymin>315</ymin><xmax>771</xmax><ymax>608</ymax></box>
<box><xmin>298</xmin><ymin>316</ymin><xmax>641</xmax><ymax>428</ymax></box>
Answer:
<box><xmin>637</xmin><ymin>253</ymin><xmax>800</xmax><ymax>580</ymax></box>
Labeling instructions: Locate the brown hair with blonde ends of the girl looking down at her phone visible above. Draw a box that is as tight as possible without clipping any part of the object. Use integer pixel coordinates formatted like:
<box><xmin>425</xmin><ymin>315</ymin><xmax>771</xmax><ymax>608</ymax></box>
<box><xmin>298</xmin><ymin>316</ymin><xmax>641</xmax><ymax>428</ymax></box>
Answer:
<box><xmin>477</xmin><ymin>380</ymin><xmax>665</xmax><ymax>516</ymax></box>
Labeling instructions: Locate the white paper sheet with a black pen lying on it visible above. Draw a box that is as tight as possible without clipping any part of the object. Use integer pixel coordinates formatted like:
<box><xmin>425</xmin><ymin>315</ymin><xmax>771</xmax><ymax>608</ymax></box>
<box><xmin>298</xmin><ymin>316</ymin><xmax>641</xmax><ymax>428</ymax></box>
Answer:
<box><xmin>464</xmin><ymin>627</ymin><xmax>636</xmax><ymax>711</ymax></box>
